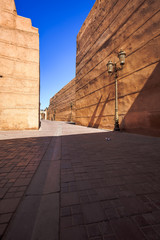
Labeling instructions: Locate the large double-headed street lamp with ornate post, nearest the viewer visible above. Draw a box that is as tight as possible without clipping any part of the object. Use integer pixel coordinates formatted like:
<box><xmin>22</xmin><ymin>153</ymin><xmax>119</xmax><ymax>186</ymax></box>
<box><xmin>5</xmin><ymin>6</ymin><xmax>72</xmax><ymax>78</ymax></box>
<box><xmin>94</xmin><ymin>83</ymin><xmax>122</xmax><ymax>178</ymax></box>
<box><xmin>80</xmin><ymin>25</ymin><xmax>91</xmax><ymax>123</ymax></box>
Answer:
<box><xmin>107</xmin><ymin>50</ymin><xmax>126</xmax><ymax>131</ymax></box>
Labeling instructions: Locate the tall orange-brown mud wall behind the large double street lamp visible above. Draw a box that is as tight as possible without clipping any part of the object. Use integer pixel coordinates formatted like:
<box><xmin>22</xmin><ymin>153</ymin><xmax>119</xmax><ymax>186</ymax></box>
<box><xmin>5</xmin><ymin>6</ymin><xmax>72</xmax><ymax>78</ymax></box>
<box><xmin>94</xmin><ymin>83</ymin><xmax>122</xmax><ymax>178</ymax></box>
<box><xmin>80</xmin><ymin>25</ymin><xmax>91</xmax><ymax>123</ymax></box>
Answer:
<box><xmin>76</xmin><ymin>0</ymin><xmax>160</xmax><ymax>135</ymax></box>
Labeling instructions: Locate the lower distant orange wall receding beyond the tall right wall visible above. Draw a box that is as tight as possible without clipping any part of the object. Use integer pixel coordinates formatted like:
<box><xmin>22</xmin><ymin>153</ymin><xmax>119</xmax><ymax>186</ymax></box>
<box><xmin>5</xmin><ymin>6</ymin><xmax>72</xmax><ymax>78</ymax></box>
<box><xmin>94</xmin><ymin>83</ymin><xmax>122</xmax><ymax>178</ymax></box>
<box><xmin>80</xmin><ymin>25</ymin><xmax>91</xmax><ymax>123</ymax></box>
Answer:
<box><xmin>47</xmin><ymin>78</ymin><xmax>75</xmax><ymax>122</ymax></box>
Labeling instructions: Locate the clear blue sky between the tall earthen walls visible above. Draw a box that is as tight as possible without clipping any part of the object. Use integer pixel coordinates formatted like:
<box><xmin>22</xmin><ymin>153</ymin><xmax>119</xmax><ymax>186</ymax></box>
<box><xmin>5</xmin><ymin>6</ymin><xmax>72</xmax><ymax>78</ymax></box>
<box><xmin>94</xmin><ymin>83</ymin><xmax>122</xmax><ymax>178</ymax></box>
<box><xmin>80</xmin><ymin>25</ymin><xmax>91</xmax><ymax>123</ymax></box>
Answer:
<box><xmin>15</xmin><ymin>0</ymin><xmax>95</xmax><ymax>109</ymax></box>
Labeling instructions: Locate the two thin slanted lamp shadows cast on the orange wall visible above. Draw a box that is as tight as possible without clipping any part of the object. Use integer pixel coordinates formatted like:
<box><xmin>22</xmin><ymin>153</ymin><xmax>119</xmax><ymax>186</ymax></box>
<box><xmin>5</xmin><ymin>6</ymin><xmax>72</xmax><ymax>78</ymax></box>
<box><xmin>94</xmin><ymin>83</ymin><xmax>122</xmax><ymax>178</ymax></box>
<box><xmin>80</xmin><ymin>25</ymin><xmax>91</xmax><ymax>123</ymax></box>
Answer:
<box><xmin>88</xmin><ymin>93</ymin><xmax>110</xmax><ymax>128</ymax></box>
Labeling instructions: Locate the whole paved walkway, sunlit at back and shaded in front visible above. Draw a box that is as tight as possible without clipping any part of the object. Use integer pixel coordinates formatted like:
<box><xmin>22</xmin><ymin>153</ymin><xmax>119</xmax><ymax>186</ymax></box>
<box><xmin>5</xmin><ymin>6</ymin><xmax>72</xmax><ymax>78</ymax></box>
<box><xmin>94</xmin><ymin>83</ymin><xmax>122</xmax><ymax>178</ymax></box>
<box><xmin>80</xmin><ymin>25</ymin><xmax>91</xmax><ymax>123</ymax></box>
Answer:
<box><xmin>0</xmin><ymin>121</ymin><xmax>160</xmax><ymax>240</ymax></box>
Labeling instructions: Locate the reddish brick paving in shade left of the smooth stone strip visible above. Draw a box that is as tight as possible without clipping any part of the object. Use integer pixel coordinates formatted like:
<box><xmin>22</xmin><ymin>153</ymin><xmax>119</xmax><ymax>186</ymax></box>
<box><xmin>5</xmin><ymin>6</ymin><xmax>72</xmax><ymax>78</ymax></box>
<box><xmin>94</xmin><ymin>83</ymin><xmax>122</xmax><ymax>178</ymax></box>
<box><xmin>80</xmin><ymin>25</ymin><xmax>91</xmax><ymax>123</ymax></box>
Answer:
<box><xmin>0</xmin><ymin>137</ymin><xmax>51</xmax><ymax>236</ymax></box>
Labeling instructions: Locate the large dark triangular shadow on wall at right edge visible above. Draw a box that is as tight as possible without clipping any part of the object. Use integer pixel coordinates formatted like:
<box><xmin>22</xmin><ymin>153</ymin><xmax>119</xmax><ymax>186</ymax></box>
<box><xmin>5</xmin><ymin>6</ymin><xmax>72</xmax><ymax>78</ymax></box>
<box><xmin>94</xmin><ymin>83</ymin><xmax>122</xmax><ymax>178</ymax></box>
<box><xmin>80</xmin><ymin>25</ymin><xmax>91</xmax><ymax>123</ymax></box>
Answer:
<box><xmin>120</xmin><ymin>63</ymin><xmax>160</xmax><ymax>136</ymax></box>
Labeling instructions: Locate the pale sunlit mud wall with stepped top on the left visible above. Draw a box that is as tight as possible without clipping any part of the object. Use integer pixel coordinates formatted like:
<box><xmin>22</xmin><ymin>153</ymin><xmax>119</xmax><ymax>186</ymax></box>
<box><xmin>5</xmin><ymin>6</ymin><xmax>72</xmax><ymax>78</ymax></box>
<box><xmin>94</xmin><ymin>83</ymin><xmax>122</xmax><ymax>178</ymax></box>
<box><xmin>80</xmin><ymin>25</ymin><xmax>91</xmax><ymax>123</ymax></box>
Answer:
<box><xmin>0</xmin><ymin>0</ymin><xmax>39</xmax><ymax>130</ymax></box>
